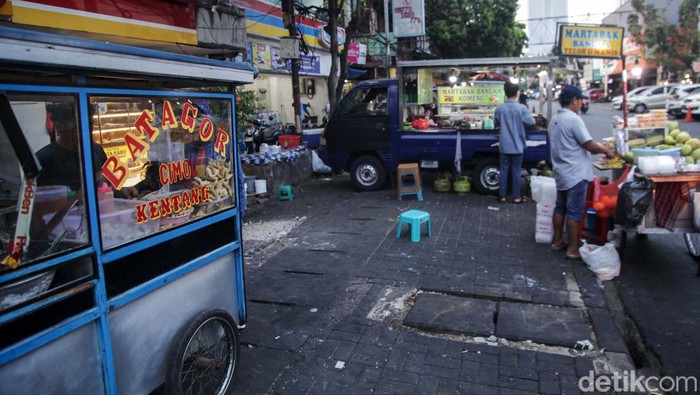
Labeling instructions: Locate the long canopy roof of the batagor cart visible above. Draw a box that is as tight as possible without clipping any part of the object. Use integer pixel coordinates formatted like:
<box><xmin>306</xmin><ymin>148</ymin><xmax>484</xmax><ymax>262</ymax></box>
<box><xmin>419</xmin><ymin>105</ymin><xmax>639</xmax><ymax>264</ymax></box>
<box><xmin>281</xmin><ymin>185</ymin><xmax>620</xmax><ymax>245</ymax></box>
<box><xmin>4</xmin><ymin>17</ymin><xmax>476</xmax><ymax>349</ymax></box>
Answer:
<box><xmin>0</xmin><ymin>27</ymin><xmax>257</xmax><ymax>88</ymax></box>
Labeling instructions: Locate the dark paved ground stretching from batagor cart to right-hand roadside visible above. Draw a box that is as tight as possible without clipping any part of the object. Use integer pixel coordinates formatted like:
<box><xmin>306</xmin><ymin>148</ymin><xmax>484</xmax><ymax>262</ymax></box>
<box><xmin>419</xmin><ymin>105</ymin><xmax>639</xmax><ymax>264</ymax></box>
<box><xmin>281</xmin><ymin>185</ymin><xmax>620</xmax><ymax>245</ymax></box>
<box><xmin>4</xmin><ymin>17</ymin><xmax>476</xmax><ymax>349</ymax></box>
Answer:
<box><xmin>231</xmin><ymin>173</ymin><xmax>700</xmax><ymax>394</ymax></box>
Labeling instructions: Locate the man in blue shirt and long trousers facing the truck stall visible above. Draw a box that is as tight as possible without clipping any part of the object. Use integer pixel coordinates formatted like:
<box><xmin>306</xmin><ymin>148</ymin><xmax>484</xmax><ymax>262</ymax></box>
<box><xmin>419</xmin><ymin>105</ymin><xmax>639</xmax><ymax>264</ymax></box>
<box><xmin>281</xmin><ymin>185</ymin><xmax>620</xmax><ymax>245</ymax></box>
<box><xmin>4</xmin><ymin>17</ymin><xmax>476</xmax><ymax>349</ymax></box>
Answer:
<box><xmin>494</xmin><ymin>82</ymin><xmax>535</xmax><ymax>203</ymax></box>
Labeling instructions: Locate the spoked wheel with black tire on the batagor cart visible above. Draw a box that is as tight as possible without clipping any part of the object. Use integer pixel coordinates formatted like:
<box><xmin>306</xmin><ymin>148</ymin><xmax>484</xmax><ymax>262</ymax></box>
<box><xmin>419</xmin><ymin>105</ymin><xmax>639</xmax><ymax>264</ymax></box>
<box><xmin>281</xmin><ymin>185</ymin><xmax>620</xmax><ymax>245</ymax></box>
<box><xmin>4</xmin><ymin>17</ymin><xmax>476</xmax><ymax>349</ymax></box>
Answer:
<box><xmin>165</xmin><ymin>310</ymin><xmax>240</xmax><ymax>395</ymax></box>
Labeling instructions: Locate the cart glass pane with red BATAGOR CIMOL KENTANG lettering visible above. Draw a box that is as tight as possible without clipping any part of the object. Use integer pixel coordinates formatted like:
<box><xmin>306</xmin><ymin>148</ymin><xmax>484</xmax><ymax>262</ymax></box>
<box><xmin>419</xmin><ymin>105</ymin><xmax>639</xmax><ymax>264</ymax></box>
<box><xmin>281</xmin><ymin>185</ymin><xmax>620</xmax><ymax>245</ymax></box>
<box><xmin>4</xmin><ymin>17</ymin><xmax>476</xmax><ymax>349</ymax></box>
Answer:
<box><xmin>89</xmin><ymin>96</ymin><xmax>236</xmax><ymax>249</ymax></box>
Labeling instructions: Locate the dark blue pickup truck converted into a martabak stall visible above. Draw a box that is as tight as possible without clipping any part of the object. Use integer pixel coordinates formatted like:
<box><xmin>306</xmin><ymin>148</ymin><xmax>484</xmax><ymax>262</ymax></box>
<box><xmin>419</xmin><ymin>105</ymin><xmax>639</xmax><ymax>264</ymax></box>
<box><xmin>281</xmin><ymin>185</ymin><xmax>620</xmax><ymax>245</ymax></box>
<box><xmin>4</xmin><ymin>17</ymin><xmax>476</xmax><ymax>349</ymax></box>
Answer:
<box><xmin>322</xmin><ymin>58</ymin><xmax>551</xmax><ymax>194</ymax></box>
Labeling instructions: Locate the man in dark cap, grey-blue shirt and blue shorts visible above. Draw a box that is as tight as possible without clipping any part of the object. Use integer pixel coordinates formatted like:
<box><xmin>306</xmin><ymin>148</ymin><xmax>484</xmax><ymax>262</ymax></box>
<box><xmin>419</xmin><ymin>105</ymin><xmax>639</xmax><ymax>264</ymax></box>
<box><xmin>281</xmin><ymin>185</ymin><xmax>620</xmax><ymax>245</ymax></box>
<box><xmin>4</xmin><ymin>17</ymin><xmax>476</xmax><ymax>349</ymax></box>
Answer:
<box><xmin>547</xmin><ymin>85</ymin><xmax>615</xmax><ymax>260</ymax></box>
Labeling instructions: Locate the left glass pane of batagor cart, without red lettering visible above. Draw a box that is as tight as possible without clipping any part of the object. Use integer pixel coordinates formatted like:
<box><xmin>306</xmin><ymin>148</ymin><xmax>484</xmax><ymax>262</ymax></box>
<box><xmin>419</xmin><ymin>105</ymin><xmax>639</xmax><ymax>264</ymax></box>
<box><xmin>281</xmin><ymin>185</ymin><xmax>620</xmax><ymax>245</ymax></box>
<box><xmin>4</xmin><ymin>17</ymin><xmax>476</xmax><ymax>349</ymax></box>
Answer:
<box><xmin>0</xmin><ymin>94</ymin><xmax>91</xmax><ymax>270</ymax></box>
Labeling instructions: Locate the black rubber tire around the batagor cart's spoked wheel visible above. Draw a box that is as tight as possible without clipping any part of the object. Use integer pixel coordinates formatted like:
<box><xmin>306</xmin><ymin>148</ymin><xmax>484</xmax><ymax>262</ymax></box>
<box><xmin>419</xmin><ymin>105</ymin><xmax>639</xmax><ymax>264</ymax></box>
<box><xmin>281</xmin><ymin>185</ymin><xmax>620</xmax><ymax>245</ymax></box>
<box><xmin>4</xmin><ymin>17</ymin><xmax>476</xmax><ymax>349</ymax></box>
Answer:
<box><xmin>165</xmin><ymin>309</ymin><xmax>241</xmax><ymax>395</ymax></box>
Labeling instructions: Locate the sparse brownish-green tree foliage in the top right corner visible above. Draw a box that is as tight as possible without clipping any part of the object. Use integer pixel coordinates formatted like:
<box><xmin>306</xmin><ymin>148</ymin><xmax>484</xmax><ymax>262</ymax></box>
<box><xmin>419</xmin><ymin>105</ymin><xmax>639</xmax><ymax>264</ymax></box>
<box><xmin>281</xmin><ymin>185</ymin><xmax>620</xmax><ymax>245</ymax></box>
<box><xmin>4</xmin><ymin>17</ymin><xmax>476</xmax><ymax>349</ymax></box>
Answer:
<box><xmin>627</xmin><ymin>0</ymin><xmax>700</xmax><ymax>77</ymax></box>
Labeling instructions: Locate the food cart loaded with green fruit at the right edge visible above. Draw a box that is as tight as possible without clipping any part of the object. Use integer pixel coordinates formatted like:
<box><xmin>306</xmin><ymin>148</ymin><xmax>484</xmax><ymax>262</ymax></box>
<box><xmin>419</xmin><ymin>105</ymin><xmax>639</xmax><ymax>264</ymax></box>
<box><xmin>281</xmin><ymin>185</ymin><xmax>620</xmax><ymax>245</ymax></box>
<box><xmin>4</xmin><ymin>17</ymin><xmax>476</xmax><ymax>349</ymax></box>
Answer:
<box><xmin>596</xmin><ymin>115</ymin><xmax>700</xmax><ymax>262</ymax></box>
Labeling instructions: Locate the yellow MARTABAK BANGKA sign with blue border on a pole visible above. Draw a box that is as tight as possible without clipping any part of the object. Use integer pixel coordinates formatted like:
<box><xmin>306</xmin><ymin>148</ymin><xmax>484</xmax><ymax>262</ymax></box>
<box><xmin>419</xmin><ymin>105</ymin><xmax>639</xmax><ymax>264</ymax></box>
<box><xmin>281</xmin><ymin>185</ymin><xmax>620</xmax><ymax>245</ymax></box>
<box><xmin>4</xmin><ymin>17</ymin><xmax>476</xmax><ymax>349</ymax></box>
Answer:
<box><xmin>558</xmin><ymin>24</ymin><xmax>625</xmax><ymax>58</ymax></box>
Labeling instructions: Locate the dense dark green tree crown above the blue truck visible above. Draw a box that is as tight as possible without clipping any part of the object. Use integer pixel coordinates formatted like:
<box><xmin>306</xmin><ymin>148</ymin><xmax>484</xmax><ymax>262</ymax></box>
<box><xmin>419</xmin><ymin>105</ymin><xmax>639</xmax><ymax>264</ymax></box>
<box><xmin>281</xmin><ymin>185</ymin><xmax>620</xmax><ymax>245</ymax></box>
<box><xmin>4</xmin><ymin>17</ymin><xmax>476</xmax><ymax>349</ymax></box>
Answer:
<box><xmin>425</xmin><ymin>0</ymin><xmax>527</xmax><ymax>59</ymax></box>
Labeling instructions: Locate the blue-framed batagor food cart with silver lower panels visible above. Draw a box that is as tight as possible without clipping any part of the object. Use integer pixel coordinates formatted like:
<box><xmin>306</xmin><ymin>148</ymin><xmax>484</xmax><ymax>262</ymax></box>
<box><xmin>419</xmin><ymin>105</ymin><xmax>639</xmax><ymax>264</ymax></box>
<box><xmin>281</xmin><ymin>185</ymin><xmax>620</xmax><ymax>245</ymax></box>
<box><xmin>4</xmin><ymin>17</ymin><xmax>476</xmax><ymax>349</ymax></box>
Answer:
<box><xmin>0</xmin><ymin>27</ymin><xmax>255</xmax><ymax>394</ymax></box>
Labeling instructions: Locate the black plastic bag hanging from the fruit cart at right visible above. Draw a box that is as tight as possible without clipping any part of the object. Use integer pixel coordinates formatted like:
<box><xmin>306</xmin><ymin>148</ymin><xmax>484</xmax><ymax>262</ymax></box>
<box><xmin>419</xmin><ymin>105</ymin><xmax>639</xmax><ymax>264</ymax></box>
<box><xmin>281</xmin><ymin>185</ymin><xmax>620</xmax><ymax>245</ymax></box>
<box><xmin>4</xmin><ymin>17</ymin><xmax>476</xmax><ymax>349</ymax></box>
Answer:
<box><xmin>615</xmin><ymin>178</ymin><xmax>654</xmax><ymax>230</ymax></box>
